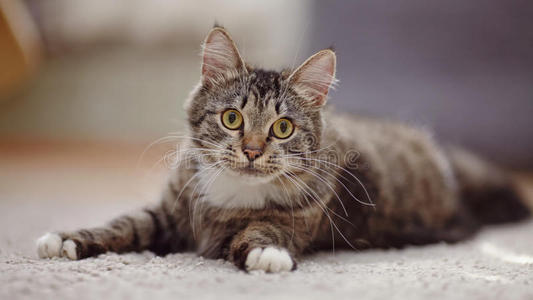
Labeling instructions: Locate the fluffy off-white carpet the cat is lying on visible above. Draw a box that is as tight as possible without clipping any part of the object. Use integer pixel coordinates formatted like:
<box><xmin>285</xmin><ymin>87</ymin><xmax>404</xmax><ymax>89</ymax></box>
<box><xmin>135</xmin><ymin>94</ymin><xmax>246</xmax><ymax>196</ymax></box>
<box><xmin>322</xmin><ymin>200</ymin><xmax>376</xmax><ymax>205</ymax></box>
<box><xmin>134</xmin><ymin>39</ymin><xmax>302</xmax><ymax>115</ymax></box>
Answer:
<box><xmin>0</xmin><ymin>198</ymin><xmax>533</xmax><ymax>299</ymax></box>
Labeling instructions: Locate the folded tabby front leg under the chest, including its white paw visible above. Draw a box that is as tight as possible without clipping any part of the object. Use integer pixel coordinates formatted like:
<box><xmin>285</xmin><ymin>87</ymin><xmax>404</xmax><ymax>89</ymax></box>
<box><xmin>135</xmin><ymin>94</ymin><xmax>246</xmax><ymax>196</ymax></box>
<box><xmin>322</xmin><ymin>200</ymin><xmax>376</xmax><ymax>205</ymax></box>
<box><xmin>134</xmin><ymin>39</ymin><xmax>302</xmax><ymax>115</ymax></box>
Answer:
<box><xmin>229</xmin><ymin>222</ymin><xmax>310</xmax><ymax>272</ymax></box>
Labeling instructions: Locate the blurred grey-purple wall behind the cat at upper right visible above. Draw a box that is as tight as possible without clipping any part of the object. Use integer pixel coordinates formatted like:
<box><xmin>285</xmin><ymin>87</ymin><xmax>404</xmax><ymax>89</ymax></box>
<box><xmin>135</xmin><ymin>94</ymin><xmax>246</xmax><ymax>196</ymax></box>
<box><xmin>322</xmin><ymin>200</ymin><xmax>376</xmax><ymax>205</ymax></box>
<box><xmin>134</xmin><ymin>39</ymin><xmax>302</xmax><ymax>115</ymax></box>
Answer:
<box><xmin>308</xmin><ymin>0</ymin><xmax>533</xmax><ymax>167</ymax></box>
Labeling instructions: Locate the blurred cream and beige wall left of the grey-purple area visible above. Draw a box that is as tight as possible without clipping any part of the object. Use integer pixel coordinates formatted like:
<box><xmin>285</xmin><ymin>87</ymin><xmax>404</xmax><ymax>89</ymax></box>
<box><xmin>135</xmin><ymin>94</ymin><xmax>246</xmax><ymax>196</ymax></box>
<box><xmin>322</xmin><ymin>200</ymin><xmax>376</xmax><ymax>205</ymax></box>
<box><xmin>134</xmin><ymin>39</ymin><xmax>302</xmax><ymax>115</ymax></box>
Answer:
<box><xmin>0</xmin><ymin>0</ymin><xmax>312</xmax><ymax>143</ymax></box>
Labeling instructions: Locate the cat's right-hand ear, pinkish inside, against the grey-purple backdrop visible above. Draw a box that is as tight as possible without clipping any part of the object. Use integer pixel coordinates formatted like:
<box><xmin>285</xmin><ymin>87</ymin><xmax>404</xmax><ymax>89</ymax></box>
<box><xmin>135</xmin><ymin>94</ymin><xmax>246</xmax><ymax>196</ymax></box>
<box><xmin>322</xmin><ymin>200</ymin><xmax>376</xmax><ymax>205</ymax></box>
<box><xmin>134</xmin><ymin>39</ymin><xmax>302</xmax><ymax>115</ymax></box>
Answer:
<box><xmin>289</xmin><ymin>49</ymin><xmax>337</xmax><ymax>107</ymax></box>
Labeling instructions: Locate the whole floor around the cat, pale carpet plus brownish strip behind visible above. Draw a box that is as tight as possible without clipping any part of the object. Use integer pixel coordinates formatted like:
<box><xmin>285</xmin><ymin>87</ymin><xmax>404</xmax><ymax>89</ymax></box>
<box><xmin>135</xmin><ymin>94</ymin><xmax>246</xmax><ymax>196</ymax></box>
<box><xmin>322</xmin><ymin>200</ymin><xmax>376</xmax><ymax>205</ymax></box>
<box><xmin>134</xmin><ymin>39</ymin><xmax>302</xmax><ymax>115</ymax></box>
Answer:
<box><xmin>0</xmin><ymin>141</ymin><xmax>533</xmax><ymax>299</ymax></box>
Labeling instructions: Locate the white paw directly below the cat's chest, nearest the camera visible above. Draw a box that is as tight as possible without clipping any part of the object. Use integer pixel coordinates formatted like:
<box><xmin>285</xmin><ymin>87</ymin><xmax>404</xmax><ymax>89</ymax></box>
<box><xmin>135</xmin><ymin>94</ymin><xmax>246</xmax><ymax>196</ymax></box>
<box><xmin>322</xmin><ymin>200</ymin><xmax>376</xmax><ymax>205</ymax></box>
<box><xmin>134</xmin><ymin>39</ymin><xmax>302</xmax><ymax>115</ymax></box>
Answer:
<box><xmin>245</xmin><ymin>247</ymin><xmax>294</xmax><ymax>273</ymax></box>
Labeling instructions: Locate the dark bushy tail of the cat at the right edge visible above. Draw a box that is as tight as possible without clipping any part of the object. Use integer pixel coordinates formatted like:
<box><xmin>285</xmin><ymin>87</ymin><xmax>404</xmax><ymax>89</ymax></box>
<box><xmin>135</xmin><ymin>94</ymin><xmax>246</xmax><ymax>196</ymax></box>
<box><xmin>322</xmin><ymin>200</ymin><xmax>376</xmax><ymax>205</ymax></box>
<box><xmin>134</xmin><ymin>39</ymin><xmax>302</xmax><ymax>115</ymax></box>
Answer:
<box><xmin>448</xmin><ymin>148</ymin><xmax>531</xmax><ymax>224</ymax></box>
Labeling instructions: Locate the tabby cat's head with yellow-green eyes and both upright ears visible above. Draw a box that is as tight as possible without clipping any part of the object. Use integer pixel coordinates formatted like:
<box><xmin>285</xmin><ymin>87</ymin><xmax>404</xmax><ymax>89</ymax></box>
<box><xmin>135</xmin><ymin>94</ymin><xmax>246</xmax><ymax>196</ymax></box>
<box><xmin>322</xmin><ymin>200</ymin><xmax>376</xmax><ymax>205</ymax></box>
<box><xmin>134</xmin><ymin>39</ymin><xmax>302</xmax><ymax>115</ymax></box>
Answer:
<box><xmin>186</xmin><ymin>27</ymin><xmax>336</xmax><ymax>183</ymax></box>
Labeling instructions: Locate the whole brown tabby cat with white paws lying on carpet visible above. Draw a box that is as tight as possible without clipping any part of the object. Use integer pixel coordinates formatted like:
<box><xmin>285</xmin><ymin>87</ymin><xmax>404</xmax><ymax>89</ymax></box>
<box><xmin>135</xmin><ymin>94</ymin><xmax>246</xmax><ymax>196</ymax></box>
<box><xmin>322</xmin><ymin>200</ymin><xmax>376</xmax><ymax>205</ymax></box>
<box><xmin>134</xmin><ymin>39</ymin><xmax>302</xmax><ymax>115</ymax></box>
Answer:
<box><xmin>37</xmin><ymin>26</ymin><xmax>530</xmax><ymax>272</ymax></box>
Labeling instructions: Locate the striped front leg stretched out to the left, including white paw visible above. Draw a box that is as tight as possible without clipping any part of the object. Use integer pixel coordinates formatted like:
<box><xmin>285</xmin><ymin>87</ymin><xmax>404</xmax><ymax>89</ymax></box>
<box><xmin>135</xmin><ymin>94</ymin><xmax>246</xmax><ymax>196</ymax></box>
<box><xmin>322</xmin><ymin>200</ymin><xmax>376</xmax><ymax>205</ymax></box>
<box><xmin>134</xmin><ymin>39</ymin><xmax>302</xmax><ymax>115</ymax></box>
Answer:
<box><xmin>37</xmin><ymin>205</ymin><xmax>185</xmax><ymax>259</ymax></box>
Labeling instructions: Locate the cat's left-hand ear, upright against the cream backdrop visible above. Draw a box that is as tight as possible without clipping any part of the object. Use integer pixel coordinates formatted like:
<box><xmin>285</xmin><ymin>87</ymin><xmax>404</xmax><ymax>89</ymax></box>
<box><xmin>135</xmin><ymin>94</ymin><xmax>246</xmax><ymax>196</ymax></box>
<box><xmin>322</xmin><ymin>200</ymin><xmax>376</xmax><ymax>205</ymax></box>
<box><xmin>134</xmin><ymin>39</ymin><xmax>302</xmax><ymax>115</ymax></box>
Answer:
<box><xmin>202</xmin><ymin>26</ymin><xmax>246</xmax><ymax>83</ymax></box>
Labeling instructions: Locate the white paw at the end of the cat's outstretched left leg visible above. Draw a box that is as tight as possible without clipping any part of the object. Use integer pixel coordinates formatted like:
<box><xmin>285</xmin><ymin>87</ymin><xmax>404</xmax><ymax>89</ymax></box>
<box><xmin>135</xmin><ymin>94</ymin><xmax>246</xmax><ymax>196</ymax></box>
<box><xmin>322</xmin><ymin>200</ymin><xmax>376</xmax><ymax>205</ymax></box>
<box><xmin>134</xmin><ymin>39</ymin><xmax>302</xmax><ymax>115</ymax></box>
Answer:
<box><xmin>37</xmin><ymin>233</ymin><xmax>78</xmax><ymax>260</ymax></box>
